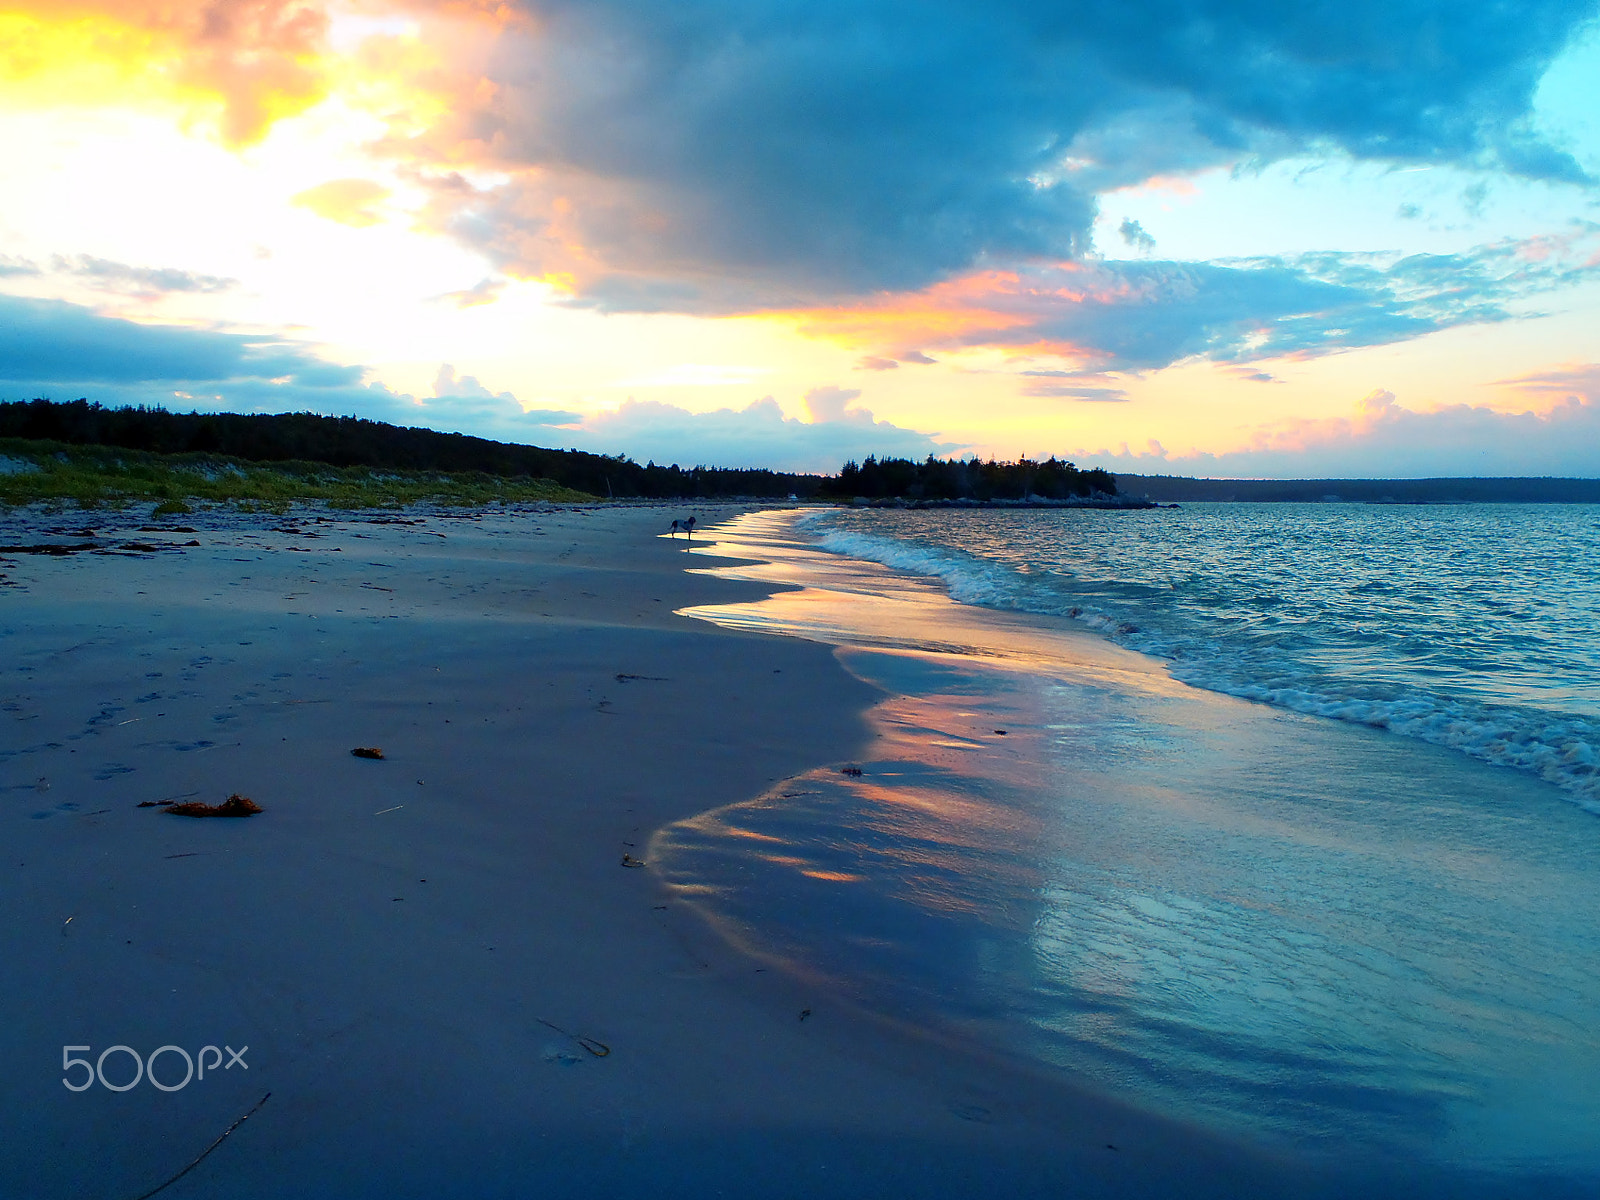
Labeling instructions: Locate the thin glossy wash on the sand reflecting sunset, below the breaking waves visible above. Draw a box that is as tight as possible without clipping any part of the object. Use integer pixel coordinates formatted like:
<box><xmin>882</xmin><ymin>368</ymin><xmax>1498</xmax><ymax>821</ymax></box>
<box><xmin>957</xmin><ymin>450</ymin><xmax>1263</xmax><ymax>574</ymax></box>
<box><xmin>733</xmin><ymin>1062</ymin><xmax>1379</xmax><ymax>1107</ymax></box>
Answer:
<box><xmin>653</xmin><ymin>515</ymin><xmax>1600</xmax><ymax>1182</ymax></box>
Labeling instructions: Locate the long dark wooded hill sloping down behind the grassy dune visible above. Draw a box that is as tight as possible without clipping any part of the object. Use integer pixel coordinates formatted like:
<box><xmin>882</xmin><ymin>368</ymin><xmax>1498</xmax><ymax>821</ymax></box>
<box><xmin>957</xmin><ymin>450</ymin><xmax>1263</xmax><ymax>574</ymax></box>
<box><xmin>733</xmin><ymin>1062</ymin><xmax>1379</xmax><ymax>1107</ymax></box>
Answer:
<box><xmin>0</xmin><ymin>400</ymin><xmax>822</xmax><ymax>498</ymax></box>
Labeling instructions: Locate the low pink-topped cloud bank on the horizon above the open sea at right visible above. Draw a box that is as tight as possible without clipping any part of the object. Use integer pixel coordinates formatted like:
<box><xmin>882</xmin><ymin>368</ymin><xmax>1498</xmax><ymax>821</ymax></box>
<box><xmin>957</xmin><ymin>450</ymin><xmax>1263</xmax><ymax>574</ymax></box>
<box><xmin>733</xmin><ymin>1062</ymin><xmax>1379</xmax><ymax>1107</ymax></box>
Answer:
<box><xmin>1074</xmin><ymin>387</ymin><xmax>1600</xmax><ymax>478</ymax></box>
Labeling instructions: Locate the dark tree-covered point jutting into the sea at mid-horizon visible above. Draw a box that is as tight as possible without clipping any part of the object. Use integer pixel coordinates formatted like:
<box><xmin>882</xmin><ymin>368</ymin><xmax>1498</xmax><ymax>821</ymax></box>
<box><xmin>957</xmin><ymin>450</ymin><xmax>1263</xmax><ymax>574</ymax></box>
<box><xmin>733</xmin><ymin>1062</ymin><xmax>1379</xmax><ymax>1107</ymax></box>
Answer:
<box><xmin>818</xmin><ymin>454</ymin><xmax>1117</xmax><ymax>501</ymax></box>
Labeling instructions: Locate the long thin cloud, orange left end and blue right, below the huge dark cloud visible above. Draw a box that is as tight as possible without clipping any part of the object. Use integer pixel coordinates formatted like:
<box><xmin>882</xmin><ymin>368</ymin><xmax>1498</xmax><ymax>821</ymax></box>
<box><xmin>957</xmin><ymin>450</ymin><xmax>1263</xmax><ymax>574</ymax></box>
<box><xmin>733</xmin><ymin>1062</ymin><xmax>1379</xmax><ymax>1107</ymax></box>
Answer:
<box><xmin>794</xmin><ymin>222</ymin><xmax>1600</xmax><ymax>370</ymax></box>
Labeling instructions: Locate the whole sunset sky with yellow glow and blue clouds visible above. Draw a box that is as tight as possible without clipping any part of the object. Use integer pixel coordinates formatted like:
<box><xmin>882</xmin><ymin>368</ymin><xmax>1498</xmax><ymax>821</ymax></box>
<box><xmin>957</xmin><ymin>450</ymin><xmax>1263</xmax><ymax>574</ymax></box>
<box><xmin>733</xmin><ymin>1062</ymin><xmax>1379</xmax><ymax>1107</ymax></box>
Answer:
<box><xmin>0</xmin><ymin>0</ymin><xmax>1600</xmax><ymax>478</ymax></box>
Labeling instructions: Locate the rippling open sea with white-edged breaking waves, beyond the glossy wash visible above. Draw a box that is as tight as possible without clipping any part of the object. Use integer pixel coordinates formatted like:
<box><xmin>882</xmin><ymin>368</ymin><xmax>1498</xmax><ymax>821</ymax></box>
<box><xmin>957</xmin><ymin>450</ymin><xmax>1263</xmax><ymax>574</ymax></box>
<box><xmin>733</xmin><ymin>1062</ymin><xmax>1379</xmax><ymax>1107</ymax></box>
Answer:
<box><xmin>805</xmin><ymin>504</ymin><xmax>1600</xmax><ymax>813</ymax></box>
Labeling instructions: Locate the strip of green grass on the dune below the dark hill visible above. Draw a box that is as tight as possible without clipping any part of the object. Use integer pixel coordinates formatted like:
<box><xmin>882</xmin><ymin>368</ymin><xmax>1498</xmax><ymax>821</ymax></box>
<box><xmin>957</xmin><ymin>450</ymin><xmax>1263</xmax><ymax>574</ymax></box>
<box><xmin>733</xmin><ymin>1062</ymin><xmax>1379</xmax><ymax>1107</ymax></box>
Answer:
<box><xmin>0</xmin><ymin>438</ymin><xmax>594</xmax><ymax>514</ymax></box>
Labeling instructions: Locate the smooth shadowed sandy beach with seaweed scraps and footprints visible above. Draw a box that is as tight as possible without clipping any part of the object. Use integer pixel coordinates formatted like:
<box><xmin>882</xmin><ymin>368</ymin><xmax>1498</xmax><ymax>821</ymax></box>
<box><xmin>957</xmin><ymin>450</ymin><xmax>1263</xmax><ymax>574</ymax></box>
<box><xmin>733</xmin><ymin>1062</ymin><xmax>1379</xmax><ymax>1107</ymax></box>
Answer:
<box><xmin>0</xmin><ymin>507</ymin><xmax>1376</xmax><ymax>1200</ymax></box>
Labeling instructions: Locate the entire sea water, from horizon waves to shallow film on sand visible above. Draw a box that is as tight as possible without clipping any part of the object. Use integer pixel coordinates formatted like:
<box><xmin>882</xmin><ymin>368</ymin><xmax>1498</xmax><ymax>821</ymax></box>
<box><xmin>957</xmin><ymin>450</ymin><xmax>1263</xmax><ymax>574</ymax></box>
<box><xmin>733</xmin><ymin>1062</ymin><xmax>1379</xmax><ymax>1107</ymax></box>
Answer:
<box><xmin>653</xmin><ymin>504</ymin><xmax>1600</xmax><ymax>1194</ymax></box>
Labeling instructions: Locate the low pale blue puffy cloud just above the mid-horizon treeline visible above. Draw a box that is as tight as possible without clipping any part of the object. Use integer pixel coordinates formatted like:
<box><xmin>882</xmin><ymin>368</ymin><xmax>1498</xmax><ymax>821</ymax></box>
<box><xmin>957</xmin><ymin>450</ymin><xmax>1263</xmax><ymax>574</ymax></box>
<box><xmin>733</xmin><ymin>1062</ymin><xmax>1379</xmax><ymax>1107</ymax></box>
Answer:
<box><xmin>570</xmin><ymin>387</ymin><xmax>963</xmax><ymax>472</ymax></box>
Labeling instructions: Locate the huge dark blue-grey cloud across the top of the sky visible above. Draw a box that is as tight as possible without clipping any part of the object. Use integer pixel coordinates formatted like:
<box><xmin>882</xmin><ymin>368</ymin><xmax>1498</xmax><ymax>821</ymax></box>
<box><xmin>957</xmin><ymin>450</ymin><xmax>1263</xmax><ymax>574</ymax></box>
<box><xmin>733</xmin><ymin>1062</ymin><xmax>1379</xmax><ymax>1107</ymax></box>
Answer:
<box><xmin>413</xmin><ymin>0</ymin><xmax>1595</xmax><ymax>312</ymax></box>
